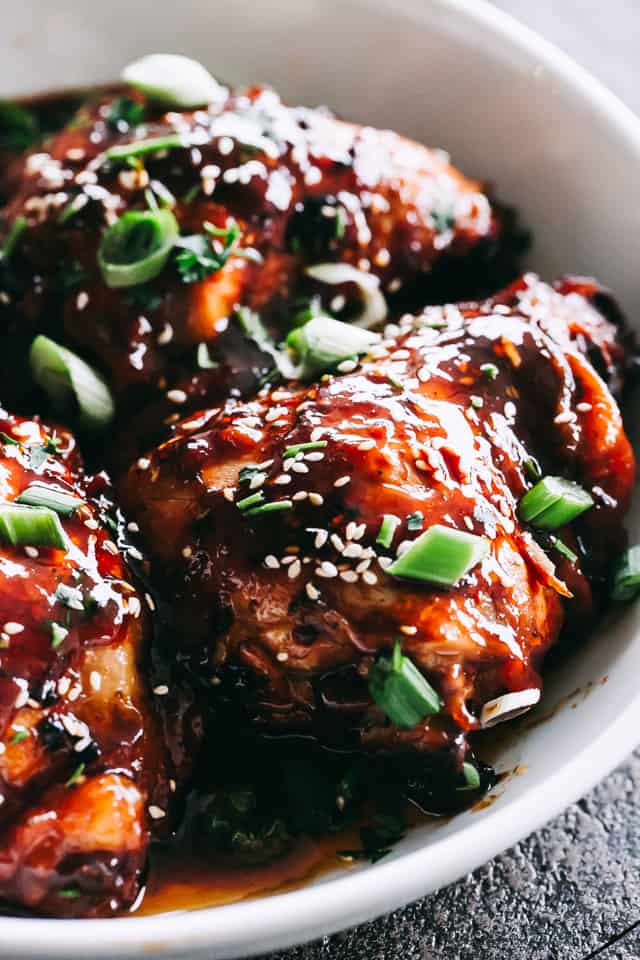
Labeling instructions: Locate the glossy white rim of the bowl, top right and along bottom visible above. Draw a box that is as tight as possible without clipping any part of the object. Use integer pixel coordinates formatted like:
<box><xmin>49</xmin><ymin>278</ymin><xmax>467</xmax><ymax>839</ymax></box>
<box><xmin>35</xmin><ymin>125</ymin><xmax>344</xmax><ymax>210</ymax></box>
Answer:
<box><xmin>0</xmin><ymin>0</ymin><xmax>640</xmax><ymax>960</ymax></box>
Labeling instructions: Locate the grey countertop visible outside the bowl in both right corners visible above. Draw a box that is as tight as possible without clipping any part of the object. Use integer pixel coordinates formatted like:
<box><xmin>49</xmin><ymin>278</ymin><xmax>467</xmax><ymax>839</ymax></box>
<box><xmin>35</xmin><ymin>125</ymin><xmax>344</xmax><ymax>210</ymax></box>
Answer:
<box><xmin>265</xmin><ymin>0</ymin><xmax>640</xmax><ymax>960</ymax></box>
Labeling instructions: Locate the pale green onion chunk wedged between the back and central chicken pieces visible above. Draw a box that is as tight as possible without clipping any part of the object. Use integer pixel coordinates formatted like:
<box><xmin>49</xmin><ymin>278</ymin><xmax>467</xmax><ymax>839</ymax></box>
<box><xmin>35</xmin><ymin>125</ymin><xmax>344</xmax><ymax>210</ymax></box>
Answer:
<box><xmin>287</xmin><ymin>317</ymin><xmax>380</xmax><ymax>378</ymax></box>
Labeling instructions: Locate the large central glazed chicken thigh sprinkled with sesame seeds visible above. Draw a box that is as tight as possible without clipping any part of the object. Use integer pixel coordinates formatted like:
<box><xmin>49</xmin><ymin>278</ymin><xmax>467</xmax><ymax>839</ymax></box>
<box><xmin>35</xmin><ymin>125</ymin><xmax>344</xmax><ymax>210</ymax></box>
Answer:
<box><xmin>122</xmin><ymin>276</ymin><xmax>634</xmax><ymax>765</ymax></box>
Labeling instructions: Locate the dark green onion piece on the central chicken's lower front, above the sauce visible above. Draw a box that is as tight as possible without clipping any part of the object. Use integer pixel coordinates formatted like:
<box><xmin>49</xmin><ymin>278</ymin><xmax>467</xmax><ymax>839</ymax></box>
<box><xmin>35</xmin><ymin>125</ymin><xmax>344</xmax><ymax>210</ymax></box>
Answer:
<box><xmin>369</xmin><ymin>641</ymin><xmax>442</xmax><ymax>730</ymax></box>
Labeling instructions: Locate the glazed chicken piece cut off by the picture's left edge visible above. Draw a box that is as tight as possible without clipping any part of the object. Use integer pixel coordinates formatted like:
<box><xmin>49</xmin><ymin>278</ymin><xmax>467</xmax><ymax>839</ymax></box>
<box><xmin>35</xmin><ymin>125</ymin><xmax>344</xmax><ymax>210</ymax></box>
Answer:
<box><xmin>0</xmin><ymin>411</ymin><xmax>169</xmax><ymax>916</ymax></box>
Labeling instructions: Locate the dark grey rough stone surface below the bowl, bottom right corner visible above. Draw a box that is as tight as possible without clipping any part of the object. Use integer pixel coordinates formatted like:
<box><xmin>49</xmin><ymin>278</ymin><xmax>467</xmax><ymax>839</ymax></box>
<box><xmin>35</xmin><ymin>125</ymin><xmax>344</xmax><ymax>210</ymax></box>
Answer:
<box><xmin>262</xmin><ymin>751</ymin><xmax>640</xmax><ymax>960</ymax></box>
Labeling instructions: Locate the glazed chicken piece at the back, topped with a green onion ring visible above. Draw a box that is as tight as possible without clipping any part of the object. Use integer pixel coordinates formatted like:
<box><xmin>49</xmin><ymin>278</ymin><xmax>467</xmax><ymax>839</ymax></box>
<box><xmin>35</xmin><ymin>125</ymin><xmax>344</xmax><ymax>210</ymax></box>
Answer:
<box><xmin>3</xmin><ymin>87</ymin><xmax>513</xmax><ymax>417</ymax></box>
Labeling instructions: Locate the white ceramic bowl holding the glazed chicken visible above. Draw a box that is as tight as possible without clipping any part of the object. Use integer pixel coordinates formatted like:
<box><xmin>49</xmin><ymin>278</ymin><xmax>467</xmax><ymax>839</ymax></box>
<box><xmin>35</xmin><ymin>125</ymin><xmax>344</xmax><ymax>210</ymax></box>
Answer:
<box><xmin>0</xmin><ymin>0</ymin><xmax>640</xmax><ymax>960</ymax></box>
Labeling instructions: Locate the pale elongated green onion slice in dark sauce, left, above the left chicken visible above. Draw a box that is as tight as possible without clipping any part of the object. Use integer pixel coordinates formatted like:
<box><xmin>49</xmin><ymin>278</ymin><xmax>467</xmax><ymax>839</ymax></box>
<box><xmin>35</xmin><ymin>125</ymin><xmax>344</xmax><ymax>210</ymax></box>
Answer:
<box><xmin>29</xmin><ymin>335</ymin><xmax>115</xmax><ymax>430</ymax></box>
